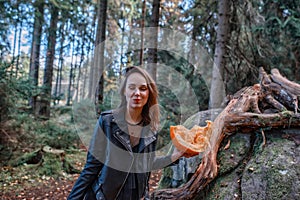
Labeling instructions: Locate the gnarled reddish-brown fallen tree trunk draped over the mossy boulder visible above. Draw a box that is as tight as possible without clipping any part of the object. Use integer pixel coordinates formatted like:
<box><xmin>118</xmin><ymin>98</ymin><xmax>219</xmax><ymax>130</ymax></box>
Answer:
<box><xmin>150</xmin><ymin>68</ymin><xmax>300</xmax><ymax>199</ymax></box>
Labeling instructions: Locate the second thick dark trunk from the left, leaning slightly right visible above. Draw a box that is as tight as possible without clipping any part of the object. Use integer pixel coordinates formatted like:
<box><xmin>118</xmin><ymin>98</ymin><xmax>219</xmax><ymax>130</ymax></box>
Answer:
<box><xmin>39</xmin><ymin>5</ymin><xmax>58</xmax><ymax>119</ymax></box>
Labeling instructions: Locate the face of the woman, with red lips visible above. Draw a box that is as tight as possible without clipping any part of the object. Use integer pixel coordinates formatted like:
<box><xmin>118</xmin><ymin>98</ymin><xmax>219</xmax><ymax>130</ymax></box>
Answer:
<box><xmin>124</xmin><ymin>72</ymin><xmax>149</xmax><ymax>109</ymax></box>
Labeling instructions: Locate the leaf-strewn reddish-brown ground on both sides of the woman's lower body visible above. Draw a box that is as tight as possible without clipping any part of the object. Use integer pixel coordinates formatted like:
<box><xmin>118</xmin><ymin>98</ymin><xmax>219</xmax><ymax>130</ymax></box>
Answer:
<box><xmin>0</xmin><ymin>150</ymin><xmax>161</xmax><ymax>200</ymax></box>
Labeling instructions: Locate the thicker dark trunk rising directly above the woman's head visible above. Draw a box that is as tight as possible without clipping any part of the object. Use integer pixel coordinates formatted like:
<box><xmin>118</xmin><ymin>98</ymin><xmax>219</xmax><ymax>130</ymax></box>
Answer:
<box><xmin>147</xmin><ymin>0</ymin><xmax>160</xmax><ymax>81</ymax></box>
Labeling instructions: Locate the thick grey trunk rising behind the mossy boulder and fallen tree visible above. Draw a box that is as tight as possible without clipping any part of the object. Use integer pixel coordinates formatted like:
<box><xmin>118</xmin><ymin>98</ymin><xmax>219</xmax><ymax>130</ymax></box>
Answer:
<box><xmin>210</xmin><ymin>0</ymin><xmax>230</xmax><ymax>108</ymax></box>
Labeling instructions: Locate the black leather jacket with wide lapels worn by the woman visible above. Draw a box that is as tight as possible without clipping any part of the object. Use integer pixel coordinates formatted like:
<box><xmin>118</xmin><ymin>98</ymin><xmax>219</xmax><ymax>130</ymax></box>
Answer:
<box><xmin>68</xmin><ymin>109</ymin><xmax>171</xmax><ymax>200</ymax></box>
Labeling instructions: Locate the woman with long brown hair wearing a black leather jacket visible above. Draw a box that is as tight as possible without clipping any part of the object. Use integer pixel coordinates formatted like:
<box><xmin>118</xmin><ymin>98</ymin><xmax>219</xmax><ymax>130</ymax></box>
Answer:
<box><xmin>68</xmin><ymin>67</ymin><xmax>182</xmax><ymax>200</ymax></box>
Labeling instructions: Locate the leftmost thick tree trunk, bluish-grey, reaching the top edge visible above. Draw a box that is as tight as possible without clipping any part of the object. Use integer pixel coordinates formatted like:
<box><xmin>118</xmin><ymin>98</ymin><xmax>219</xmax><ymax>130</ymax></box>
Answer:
<box><xmin>29</xmin><ymin>1</ymin><xmax>44</xmax><ymax>113</ymax></box>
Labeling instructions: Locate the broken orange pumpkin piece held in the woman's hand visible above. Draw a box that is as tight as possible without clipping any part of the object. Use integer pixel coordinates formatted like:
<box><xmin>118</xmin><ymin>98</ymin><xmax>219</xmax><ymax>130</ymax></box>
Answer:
<box><xmin>170</xmin><ymin>120</ymin><xmax>213</xmax><ymax>157</ymax></box>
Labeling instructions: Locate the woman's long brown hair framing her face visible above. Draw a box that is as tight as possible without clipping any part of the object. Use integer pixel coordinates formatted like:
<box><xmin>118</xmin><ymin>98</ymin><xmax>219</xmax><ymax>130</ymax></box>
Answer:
<box><xmin>119</xmin><ymin>66</ymin><xmax>159</xmax><ymax>131</ymax></box>
